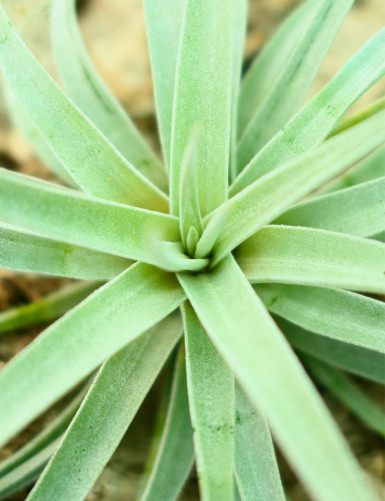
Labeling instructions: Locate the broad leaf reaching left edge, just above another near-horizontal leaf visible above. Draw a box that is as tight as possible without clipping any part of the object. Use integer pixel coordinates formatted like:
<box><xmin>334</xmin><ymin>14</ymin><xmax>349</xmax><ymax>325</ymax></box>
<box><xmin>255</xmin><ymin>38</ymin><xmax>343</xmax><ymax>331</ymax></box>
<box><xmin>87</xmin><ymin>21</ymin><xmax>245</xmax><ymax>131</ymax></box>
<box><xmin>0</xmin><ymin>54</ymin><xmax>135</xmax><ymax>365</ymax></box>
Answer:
<box><xmin>0</xmin><ymin>169</ymin><xmax>179</xmax><ymax>270</ymax></box>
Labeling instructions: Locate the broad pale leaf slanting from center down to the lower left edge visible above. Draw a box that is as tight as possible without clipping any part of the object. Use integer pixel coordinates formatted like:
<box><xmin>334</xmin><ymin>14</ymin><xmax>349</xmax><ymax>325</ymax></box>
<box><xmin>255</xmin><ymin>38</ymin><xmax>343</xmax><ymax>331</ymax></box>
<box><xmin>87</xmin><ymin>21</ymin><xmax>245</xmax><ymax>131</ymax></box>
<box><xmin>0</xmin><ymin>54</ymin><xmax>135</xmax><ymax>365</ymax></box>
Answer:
<box><xmin>0</xmin><ymin>263</ymin><xmax>184</xmax><ymax>444</ymax></box>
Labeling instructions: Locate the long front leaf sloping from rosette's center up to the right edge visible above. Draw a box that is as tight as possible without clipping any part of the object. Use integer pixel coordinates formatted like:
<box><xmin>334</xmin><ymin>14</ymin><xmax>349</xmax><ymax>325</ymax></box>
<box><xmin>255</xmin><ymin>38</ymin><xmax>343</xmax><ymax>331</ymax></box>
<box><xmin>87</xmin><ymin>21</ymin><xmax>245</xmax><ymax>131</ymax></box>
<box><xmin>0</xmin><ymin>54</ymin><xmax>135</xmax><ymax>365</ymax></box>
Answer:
<box><xmin>207</xmin><ymin>111</ymin><xmax>385</xmax><ymax>264</ymax></box>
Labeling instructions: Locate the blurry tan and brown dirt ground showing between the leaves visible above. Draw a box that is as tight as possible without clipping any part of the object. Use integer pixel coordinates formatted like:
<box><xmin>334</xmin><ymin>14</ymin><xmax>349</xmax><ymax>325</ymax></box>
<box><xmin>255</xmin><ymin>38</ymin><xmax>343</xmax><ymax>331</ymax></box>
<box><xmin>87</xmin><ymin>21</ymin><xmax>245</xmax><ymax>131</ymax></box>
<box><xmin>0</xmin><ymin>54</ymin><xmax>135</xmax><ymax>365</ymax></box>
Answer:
<box><xmin>0</xmin><ymin>0</ymin><xmax>385</xmax><ymax>501</ymax></box>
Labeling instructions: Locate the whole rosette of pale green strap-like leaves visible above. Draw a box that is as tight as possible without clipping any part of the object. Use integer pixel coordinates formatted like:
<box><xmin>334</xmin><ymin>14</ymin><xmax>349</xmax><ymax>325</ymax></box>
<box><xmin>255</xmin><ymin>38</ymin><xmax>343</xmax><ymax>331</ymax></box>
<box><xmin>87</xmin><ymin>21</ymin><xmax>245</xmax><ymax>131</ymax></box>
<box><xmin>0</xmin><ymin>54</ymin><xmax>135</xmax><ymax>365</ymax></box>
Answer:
<box><xmin>0</xmin><ymin>0</ymin><xmax>385</xmax><ymax>501</ymax></box>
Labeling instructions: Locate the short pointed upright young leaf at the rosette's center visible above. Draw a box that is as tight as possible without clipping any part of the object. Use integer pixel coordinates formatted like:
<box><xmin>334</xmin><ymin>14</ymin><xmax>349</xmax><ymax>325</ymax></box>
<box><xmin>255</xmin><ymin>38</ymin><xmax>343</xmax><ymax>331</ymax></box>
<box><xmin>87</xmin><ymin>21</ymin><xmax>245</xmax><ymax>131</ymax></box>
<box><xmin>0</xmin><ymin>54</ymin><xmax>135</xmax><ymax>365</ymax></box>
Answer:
<box><xmin>179</xmin><ymin>129</ymin><xmax>203</xmax><ymax>247</ymax></box>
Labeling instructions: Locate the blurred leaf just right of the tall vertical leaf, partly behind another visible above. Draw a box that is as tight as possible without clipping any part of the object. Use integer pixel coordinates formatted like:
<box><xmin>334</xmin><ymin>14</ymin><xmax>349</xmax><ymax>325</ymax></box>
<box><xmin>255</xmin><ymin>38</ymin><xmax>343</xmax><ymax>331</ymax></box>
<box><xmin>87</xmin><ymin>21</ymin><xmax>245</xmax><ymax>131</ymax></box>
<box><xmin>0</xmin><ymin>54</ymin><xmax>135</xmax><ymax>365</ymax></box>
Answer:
<box><xmin>238</xmin><ymin>0</ymin><xmax>318</xmax><ymax>135</ymax></box>
